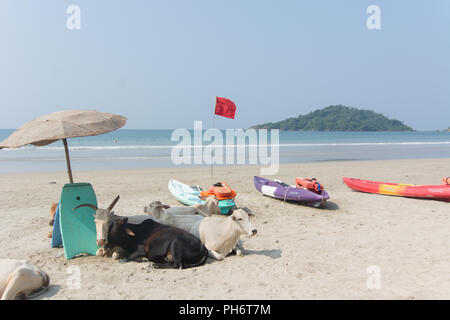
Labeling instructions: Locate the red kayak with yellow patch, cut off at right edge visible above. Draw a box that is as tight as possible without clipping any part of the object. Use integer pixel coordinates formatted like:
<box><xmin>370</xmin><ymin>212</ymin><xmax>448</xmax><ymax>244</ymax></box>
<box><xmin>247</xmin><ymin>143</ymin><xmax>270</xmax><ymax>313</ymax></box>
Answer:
<box><xmin>343</xmin><ymin>178</ymin><xmax>450</xmax><ymax>202</ymax></box>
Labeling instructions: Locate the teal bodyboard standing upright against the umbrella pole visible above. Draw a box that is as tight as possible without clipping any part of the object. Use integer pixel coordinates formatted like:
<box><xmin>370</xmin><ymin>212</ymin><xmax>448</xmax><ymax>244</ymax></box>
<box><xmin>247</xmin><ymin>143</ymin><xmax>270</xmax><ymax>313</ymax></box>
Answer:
<box><xmin>59</xmin><ymin>183</ymin><xmax>99</xmax><ymax>259</ymax></box>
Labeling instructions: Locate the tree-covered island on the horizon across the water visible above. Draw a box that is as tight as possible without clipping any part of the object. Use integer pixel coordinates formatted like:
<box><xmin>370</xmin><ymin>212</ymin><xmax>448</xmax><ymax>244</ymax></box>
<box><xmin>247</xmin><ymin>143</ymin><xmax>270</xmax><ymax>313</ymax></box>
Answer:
<box><xmin>251</xmin><ymin>105</ymin><xmax>414</xmax><ymax>131</ymax></box>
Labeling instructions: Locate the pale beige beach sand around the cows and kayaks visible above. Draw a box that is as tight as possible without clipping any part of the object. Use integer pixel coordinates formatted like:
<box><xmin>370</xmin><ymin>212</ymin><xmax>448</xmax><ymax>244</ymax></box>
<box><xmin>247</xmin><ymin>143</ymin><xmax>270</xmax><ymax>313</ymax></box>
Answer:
<box><xmin>0</xmin><ymin>159</ymin><xmax>450</xmax><ymax>299</ymax></box>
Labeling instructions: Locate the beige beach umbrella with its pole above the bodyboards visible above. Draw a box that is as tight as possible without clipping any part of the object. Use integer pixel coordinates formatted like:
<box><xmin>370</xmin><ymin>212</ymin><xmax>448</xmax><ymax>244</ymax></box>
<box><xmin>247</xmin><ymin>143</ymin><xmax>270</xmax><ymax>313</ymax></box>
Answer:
<box><xmin>0</xmin><ymin>110</ymin><xmax>127</xmax><ymax>183</ymax></box>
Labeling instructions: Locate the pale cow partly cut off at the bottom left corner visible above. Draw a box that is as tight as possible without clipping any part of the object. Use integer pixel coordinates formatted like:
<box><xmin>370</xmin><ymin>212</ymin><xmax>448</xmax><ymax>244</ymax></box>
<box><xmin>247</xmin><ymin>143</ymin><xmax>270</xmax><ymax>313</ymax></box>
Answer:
<box><xmin>0</xmin><ymin>259</ymin><xmax>50</xmax><ymax>300</ymax></box>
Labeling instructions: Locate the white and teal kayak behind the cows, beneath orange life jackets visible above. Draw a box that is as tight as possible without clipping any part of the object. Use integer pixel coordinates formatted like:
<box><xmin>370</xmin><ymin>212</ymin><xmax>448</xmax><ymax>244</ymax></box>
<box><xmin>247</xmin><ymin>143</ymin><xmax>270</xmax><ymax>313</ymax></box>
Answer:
<box><xmin>168</xmin><ymin>179</ymin><xmax>236</xmax><ymax>214</ymax></box>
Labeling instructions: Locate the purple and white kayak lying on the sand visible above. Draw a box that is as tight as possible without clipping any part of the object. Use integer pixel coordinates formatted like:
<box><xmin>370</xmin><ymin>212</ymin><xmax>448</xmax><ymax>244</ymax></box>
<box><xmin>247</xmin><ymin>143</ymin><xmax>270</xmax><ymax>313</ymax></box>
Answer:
<box><xmin>253</xmin><ymin>176</ymin><xmax>330</xmax><ymax>207</ymax></box>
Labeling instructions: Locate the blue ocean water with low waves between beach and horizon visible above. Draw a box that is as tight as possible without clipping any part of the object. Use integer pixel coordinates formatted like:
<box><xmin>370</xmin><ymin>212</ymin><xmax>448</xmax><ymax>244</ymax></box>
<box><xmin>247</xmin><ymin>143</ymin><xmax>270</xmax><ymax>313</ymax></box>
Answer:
<box><xmin>0</xmin><ymin>129</ymin><xmax>450</xmax><ymax>173</ymax></box>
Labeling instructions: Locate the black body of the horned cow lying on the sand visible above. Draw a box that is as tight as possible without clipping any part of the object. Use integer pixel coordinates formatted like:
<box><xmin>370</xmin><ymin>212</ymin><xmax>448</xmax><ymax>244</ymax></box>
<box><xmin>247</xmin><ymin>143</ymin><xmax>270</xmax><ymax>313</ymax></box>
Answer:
<box><xmin>107</xmin><ymin>218</ymin><xmax>208</xmax><ymax>269</ymax></box>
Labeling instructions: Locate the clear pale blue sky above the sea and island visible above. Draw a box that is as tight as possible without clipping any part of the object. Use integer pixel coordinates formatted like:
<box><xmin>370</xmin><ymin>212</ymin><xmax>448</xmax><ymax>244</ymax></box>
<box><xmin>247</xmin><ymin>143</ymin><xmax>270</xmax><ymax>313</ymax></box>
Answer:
<box><xmin>0</xmin><ymin>0</ymin><xmax>450</xmax><ymax>130</ymax></box>
